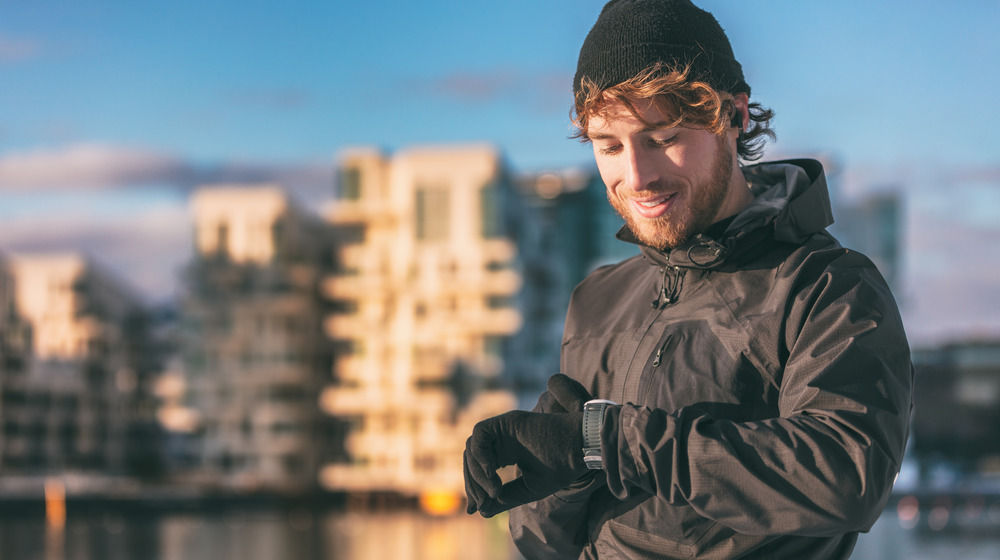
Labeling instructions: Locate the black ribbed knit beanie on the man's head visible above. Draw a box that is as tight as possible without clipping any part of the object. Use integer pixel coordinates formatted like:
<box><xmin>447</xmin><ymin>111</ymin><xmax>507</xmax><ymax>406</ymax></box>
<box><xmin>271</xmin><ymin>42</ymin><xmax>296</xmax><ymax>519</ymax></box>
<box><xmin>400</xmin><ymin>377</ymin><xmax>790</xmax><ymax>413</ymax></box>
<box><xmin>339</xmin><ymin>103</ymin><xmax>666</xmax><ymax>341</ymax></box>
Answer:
<box><xmin>573</xmin><ymin>0</ymin><xmax>750</xmax><ymax>95</ymax></box>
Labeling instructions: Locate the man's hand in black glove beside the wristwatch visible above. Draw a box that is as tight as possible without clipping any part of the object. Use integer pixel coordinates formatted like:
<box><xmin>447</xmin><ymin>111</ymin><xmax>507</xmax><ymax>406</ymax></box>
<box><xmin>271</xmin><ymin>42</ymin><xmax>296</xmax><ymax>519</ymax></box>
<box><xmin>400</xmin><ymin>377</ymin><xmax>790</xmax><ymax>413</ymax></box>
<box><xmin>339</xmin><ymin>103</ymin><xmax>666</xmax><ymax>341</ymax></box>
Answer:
<box><xmin>465</xmin><ymin>374</ymin><xmax>590</xmax><ymax>517</ymax></box>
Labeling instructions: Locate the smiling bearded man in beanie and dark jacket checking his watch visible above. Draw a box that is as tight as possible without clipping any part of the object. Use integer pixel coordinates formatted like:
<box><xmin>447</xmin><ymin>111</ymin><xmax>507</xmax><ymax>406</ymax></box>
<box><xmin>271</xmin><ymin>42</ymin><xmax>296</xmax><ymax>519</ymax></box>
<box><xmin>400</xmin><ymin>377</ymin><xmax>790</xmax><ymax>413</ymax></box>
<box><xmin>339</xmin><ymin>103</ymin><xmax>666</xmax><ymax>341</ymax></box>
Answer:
<box><xmin>465</xmin><ymin>0</ymin><xmax>913</xmax><ymax>559</ymax></box>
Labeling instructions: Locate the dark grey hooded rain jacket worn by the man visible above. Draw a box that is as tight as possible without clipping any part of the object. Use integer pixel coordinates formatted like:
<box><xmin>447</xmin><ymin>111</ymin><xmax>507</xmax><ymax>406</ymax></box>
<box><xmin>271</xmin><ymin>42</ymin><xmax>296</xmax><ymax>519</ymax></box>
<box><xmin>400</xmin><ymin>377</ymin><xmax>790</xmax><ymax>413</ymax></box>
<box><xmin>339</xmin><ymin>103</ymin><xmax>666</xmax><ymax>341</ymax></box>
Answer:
<box><xmin>510</xmin><ymin>160</ymin><xmax>913</xmax><ymax>559</ymax></box>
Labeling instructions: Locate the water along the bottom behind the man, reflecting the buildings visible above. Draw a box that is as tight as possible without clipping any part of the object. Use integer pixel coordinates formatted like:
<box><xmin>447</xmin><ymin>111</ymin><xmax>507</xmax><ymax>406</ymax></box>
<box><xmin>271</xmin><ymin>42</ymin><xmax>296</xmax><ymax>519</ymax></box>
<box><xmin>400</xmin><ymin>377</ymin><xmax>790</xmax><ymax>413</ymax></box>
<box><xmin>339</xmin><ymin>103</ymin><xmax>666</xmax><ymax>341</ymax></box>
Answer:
<box><xmin>0</xmin><ymin>509</ymin><xmax>1000</xmax><ymax>560</ymax></box>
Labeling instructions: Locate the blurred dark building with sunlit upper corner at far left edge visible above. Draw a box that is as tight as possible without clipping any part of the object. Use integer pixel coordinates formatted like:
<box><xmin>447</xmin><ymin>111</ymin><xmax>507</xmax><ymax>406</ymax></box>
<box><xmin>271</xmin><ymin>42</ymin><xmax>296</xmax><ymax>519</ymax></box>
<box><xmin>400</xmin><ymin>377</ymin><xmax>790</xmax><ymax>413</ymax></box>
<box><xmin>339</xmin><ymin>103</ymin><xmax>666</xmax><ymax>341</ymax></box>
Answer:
<box><xmin>0</xmin><ymin>254</ymin><xmax>159</xmax><ymax>476</ymax></box>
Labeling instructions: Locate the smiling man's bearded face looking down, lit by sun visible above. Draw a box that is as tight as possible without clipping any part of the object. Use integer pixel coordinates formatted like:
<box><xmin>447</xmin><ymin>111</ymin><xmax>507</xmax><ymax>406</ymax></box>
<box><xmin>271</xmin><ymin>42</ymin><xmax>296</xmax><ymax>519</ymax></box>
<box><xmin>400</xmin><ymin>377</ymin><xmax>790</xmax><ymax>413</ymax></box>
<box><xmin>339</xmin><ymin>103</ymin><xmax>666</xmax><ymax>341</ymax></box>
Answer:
<box><xmin>587</xmin><ymin>100</ymin><xmax>749</xmax><ymax>249</ymax></box>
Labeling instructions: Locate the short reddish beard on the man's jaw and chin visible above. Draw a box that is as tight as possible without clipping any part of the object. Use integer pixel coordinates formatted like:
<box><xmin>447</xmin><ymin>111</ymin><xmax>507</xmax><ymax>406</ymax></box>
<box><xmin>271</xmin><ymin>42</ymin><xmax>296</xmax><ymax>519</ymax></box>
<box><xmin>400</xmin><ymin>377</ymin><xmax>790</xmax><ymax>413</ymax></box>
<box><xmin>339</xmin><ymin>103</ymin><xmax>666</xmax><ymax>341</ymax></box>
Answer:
<box><xmin>608</xmin><ymin>135</ymin><xmax>733</xmax><ymax>249</ymax></box>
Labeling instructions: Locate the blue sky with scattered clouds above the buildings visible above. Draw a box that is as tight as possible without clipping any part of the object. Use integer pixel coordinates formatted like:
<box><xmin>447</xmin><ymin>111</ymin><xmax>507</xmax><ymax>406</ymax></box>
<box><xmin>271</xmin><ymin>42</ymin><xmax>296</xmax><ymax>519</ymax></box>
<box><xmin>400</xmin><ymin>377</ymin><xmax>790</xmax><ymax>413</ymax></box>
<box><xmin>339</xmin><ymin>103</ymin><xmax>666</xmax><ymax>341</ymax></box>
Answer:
<box><xmin>0</xmin><ymin>0</ymin><xmax>1000</xmax><ymax>339</ymax></box>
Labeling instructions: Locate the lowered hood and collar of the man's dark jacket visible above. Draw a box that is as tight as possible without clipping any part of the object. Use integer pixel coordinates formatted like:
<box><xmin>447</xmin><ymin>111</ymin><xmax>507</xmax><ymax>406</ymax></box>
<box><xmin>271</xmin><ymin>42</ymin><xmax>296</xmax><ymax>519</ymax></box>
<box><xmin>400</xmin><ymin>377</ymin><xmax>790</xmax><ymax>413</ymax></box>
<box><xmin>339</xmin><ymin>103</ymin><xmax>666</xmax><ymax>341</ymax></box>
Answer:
<box><xmin>616</xmin><ymin>159</ymin><xmax>833</xmax><ymax>268</ymax></box>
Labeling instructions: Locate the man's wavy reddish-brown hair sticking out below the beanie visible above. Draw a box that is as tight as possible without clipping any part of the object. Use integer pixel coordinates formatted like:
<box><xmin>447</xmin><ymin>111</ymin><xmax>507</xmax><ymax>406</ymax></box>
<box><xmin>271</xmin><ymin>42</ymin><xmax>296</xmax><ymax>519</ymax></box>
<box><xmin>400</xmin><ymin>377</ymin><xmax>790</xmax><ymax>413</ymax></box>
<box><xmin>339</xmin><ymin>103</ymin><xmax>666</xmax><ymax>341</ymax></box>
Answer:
<box><xmin>570</xmin><ymin>63</ymin><xmax>775</xmax><ymax>161</ymax></box>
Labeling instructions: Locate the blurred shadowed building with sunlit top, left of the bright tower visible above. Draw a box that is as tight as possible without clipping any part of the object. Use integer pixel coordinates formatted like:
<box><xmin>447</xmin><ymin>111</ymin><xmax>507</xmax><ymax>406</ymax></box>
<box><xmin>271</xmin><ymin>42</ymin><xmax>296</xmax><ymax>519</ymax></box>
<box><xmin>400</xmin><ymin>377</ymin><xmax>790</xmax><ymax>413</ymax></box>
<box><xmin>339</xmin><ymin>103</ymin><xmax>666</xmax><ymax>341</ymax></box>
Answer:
<box><xmin>186</xmin><ymin>185</ymin><xmax>335</xmax><ymax>492</ymax></box>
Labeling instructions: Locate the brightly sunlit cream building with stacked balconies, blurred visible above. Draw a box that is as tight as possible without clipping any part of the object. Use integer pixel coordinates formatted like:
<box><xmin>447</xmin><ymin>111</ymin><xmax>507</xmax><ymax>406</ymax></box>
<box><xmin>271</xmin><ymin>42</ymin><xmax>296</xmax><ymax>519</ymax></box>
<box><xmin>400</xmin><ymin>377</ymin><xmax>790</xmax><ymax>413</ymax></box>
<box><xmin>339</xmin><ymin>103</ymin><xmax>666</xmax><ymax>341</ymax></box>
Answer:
<box><xmin>321</xmin><ymin>146</ymin><xmax>525</xmax><ymax>500</ymax></box>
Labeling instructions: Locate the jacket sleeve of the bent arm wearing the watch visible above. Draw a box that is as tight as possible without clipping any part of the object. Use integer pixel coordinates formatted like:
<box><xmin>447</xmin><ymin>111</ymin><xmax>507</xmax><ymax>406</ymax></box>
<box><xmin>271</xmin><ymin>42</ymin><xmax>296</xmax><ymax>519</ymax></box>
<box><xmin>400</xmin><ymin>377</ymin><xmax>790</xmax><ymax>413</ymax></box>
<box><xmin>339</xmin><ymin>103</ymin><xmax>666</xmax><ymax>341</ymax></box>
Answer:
<box><xmin>602</xmin><ymin>259</ymin><xmax>913</xmax><ymax>536</ymax></box>
